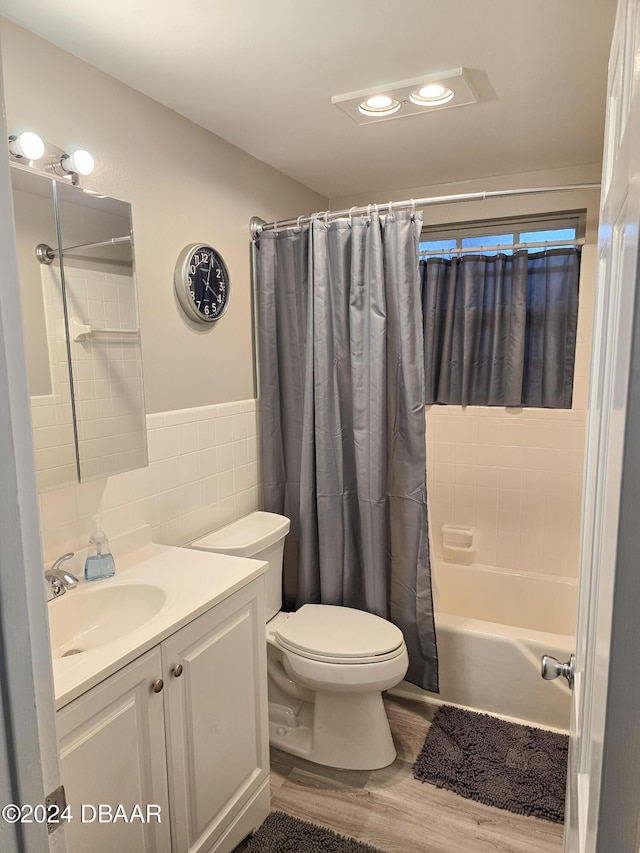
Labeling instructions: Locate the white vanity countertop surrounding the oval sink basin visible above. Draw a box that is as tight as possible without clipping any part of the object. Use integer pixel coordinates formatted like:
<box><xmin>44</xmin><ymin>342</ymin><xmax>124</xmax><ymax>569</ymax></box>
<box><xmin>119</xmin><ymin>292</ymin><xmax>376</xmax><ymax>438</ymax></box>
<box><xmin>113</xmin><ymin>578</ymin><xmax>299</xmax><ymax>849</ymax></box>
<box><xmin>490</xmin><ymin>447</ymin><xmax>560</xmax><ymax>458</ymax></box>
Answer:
<box><xmin>47</xmin><ymin>532</ymin><xmax>267</xmax><ymax>710</ymax></box>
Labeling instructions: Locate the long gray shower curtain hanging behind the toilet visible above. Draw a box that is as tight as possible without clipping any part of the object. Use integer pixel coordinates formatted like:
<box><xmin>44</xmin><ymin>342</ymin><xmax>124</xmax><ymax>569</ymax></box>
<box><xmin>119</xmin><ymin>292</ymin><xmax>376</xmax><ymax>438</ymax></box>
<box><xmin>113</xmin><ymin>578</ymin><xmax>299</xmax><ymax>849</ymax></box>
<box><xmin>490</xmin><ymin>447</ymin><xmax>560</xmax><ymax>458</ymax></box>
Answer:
<box><xmin>257</xmin><ymin>213</ymin><xmax>438</xmax><ymax>691</ymax></box>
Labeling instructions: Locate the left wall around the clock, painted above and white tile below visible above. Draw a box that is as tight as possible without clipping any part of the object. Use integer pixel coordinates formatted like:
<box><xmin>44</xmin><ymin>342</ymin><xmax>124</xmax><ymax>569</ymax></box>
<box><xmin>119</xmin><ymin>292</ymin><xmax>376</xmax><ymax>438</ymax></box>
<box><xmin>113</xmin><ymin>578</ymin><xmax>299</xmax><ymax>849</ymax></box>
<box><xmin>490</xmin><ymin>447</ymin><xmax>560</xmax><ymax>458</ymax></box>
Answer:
<box><xmin>0</xmin><ymin>20</ymin><xmax>327</xmax><ymax>561</ymax></box>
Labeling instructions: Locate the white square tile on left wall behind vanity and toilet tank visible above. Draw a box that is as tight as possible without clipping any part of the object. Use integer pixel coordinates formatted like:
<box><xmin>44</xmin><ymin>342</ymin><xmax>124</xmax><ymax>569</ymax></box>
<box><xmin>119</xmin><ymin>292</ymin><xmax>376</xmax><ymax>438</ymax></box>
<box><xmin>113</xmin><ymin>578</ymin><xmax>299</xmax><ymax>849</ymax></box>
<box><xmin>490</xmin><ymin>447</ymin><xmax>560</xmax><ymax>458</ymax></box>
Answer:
<box><xmin>40</xmin><ymin>400</ymin><xmax>261</xmax><ymax>562</ymax></box>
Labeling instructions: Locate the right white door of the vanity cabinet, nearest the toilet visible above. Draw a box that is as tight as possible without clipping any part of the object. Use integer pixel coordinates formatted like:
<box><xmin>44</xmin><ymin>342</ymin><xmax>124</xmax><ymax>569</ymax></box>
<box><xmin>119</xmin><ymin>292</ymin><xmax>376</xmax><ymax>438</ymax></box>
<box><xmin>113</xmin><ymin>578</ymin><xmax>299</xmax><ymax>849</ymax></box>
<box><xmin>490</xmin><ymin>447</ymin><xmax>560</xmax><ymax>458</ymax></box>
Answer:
<box><xmin>162</xmin><ymin>578</ymin><xmax>269</xmax><ymax>853</ymax></box>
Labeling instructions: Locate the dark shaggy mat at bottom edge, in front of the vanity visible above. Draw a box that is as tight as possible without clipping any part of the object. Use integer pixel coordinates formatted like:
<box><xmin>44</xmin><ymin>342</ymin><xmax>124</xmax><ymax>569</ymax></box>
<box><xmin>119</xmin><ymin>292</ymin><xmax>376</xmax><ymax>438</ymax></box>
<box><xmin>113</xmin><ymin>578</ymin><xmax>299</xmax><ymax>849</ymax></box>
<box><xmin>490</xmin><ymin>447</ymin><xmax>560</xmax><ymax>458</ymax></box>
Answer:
<box><xmin>245</xmin><ymin>812</ymin><xmax>382</xmax><ymax>853</ymax></box>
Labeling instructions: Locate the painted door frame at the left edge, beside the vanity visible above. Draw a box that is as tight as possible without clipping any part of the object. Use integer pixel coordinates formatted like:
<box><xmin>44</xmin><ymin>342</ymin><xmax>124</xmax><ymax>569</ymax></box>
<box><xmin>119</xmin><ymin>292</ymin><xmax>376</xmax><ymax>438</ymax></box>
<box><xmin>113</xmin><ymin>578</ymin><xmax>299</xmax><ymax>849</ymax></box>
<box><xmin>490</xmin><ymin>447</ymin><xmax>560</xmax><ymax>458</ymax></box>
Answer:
<box><xmin>0</xmin><ymin>45</ymin><xmax>65</xmax><ymax>853</ymax></box>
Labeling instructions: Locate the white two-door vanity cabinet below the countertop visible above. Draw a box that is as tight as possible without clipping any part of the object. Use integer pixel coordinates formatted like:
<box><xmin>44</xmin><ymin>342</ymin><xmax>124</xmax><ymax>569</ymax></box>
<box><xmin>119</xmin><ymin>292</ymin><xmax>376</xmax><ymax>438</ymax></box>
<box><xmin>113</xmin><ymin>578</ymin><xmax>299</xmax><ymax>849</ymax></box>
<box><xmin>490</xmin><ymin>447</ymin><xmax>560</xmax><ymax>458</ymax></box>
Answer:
<box><xmin>58</xmin><ymin>578</ymin><xmax>269</xmax><ymax>853</ymax></box>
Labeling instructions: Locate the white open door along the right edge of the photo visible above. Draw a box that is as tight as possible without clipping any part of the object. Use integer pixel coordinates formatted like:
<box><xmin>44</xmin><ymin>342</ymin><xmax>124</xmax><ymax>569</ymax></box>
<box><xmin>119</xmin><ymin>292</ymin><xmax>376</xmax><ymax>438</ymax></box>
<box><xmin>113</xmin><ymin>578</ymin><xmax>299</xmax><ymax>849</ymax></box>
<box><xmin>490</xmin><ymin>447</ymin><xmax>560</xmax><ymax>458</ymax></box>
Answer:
<box><xmin>564</xmin><ymin>0</ymin><xmax>640</xmax><ymax>853</ymax></box>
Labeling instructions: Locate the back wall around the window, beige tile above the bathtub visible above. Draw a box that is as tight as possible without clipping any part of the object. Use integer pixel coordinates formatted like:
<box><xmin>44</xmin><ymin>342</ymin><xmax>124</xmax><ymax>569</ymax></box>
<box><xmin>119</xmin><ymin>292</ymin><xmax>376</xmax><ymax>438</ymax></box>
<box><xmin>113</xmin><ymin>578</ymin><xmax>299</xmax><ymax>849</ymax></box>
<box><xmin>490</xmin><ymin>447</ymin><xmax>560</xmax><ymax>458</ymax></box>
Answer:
<box><xmin>331</xmin><ymin>165</ymin><xmax>601</xmax><ymax>577</ymax></box>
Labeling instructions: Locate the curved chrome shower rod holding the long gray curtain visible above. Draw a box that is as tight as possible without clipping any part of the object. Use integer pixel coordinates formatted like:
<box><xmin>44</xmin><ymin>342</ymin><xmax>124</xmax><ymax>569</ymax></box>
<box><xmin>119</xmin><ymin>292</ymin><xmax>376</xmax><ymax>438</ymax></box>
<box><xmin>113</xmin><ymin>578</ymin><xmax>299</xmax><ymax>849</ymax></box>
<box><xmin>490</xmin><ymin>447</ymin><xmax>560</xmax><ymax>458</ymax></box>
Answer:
<box><xmin>249</xmin><ymin>184</ymin><xmax>600</xmax><ymax>241</ymax></box>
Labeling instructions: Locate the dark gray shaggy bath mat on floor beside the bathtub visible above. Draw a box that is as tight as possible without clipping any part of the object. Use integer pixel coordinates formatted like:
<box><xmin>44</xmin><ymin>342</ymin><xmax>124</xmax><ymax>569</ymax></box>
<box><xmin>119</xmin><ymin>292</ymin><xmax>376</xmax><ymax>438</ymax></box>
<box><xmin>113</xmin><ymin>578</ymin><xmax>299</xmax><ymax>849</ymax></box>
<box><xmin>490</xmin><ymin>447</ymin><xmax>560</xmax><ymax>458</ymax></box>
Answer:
<box><xmin>413</xmin><ymin>705</ymin><xmax>569</xmax><ymax>823</ymax></box>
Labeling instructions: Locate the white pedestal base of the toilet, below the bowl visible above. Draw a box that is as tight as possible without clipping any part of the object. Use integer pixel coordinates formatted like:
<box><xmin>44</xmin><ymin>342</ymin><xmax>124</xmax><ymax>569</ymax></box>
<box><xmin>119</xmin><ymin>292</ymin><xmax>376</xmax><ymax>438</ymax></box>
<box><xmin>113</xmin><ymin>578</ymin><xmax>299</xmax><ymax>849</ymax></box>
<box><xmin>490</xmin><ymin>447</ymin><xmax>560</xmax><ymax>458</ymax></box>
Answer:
<box><xmin>269</xmin><ymin>691</ymin><xmax>396</xmax><ymax>770</ymax></box>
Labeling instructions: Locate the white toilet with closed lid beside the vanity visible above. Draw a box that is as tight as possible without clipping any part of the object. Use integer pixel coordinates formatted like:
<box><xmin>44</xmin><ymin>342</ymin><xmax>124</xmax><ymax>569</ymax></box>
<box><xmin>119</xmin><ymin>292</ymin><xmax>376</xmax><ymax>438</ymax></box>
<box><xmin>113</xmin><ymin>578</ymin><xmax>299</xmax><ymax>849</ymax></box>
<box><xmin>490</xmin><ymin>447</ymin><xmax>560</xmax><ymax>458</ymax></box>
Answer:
<box><xmin>190</xmin><ymin>512</ymin><xmax>409</xmax><ymax>770</ymax></box>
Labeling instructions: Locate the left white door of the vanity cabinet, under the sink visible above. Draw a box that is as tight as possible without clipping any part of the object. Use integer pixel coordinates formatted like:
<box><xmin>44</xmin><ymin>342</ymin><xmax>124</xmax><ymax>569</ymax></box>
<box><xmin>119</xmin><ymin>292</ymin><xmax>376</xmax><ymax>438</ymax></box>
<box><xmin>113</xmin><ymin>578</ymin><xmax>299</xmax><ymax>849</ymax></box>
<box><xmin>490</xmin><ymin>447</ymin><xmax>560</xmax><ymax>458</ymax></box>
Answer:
<box><xmin>57</xmin><ymin>648</ymin><xmax>171</xmax><ymax>853</ymax></box>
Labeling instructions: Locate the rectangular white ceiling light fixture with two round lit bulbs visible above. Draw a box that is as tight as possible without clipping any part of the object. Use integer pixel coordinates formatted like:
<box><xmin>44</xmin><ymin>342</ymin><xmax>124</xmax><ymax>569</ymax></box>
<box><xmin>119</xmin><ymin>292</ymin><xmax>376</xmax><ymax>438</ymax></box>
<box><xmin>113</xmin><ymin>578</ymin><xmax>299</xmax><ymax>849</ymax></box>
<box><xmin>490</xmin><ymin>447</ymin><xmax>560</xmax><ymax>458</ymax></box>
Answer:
<box><xmin>331</xmin><ymin>68</ymin><xmax>478</xmax><ymax>124</ymax></box>
